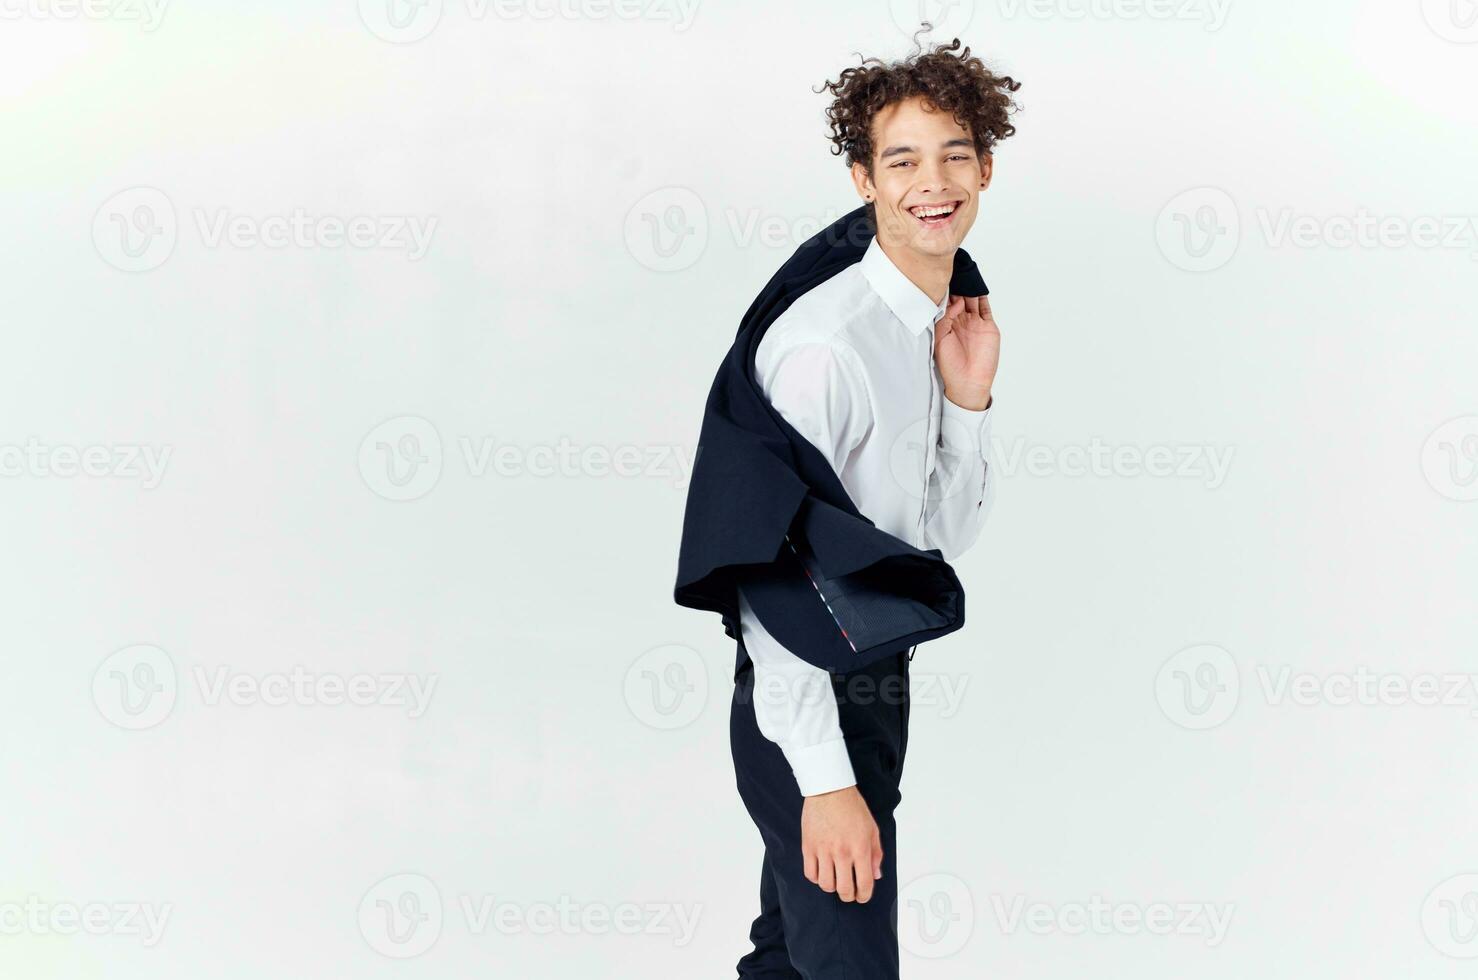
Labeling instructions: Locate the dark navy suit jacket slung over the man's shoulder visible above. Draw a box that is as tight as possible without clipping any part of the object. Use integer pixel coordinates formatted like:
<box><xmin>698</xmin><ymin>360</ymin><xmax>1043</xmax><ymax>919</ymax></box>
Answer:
<box><xmin>674</xmin><ymin>208</ymin><xmax>989</xmax><ymax>673</ymax></box>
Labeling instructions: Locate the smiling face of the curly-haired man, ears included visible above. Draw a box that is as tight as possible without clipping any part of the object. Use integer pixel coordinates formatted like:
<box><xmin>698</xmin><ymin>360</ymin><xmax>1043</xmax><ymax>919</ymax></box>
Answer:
<box><xmin>851</xmin><ymin>96</ymin><xmax>992</xmax><ymax>260</ymax></box>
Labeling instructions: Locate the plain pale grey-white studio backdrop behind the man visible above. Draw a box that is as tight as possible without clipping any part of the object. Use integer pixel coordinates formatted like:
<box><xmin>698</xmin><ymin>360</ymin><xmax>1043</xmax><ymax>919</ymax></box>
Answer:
<box><xmin>0</xmin><ymin>0</ymin><xmax>1478</xmax><ymax>980</ymax></box>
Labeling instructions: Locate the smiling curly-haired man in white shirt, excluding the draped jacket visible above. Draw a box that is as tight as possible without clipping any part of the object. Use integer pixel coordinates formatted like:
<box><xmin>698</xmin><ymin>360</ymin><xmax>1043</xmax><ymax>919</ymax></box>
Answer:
<box><xmin>680</xmin><ymin>40</ymin><xmax>1020</xmax><ymax>980</ymax></box>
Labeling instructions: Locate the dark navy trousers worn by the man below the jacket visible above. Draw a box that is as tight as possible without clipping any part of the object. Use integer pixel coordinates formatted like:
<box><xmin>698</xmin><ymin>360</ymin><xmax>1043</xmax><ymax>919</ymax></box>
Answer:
<box><xmin>729</xmin><ymin>653</ymin><xmax>909</xmax><ymax>980</ymax></box>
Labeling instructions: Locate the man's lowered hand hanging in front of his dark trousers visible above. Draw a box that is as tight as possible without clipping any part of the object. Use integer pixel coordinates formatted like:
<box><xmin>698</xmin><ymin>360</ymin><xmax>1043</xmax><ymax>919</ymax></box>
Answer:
<box><xmin>801</xmin><ymin>786</ymin><xmax>882</xmax><ymax>902</ymax></box>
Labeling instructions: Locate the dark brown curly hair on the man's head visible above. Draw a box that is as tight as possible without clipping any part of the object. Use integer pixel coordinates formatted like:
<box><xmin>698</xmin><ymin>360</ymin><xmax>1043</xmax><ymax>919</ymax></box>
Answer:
<box><xmin>816</xmin><ymin>35</ymin><xmax>1021</xmax><ymax>173</ymax></box>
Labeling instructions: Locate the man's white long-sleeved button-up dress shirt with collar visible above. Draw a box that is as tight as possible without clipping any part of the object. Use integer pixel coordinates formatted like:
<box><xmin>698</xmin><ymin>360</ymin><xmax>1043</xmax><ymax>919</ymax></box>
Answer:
<box><xmin>739</xmin><ymin>238</ymin><xmax>995</xmax><ymax>797</ymax></box>
